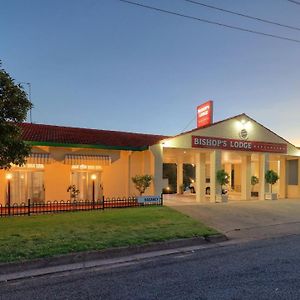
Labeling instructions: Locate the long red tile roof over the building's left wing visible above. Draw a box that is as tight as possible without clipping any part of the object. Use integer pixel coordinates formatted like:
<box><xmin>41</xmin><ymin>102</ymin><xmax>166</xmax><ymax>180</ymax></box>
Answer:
<box><xmin>20</xmin><ymin>123</ymin><xmax>167</xmax><ymax>150</ymax></box>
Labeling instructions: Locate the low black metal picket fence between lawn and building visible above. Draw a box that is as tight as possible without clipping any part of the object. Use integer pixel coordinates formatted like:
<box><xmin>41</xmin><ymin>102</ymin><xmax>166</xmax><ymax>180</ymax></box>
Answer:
<box><xmin>0</xmin><ymin>195</ymin><xmax>163</xmax><ymax>217</ymax></box>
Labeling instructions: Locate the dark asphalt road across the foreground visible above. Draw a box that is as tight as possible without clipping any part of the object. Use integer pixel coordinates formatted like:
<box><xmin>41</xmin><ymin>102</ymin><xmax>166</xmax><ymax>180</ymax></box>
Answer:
<box><xmin>0</xmin><ymin>235</ymin><xmax>300</xmax><ymax>300</ymax></box>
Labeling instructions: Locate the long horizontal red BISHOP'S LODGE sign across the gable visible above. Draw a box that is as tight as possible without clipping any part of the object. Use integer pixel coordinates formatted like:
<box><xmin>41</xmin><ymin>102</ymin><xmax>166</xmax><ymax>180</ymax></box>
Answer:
<box><xmin>192</xmin><ymin>136</ymin><xmax>287</xmax><ymax>154</ymax></box>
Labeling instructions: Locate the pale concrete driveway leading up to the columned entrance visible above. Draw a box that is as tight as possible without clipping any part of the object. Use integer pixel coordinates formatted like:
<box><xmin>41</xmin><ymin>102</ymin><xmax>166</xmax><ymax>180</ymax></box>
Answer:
<box><xmin>164</xmin><ymin>195</ymin><xmax>300</xmax><ymax>240</ymax></box>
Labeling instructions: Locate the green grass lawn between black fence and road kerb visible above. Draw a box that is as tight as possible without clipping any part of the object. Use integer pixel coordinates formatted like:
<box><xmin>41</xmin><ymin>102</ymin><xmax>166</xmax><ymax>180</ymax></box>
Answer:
<box><xmin>0</xmin><ymin>207</ymin><xmax>216</xmax><ymax>262</ymax></box>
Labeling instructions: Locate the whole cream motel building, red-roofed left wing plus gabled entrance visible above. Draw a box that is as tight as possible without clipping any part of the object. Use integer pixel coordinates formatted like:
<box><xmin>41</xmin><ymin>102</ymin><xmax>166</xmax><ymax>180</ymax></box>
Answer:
<box><xmin>0</xmin><ymin>110</ymin><xmax>300</xmax><ymax>205</ymax></box>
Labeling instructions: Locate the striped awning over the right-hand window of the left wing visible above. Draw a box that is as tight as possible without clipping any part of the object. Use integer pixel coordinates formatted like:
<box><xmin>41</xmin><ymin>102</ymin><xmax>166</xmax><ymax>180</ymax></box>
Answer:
<box><xmin>65</xmin><ymin>154</ymin><xmax>111</xmax><ymax>166</ymax></box>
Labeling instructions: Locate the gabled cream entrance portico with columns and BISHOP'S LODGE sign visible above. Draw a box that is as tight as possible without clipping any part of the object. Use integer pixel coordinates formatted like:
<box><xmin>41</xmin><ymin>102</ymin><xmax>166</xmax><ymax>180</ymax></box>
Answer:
<box><xmin>162</xmin><ymin>114</ymin><xmax>300</xmax><ymax>202</ymax></box>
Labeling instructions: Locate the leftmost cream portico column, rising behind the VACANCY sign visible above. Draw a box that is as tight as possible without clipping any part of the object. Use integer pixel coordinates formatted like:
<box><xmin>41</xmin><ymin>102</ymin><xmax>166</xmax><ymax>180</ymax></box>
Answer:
<box><xmin>149</xmin><ymin>144</ymin><xmax>163</xmax><ymax>195</ymax></box>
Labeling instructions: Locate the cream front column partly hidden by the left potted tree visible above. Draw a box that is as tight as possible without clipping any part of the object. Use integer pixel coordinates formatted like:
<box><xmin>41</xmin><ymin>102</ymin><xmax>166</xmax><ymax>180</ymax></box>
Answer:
<box><xmin>210</xmin><ymin>150</ymin><xmax>222</xmax><ymax>202</ymax></box>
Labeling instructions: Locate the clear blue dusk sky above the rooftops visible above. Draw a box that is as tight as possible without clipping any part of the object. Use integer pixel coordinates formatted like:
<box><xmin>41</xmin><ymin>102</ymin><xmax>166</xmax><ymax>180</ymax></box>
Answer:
<box><xmin>0</xmin><ymin>0</ymin><xmax>300</xmax><ymax>145</ymax></box>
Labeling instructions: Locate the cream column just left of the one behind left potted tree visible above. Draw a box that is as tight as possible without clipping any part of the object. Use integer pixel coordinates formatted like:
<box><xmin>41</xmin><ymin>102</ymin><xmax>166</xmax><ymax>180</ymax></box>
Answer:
<box><xmin>195</xmin><ymin>152</ymin><xmax>205</xmax><ymax>202</ymax></box>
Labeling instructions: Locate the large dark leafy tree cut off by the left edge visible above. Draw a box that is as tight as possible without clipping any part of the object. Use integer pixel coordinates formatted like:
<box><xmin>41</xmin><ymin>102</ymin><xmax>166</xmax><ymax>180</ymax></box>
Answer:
<box><xmin>0</xmin><ymin>61</ymin><xmax>32</xmax><ymax>169</ymax></box>
